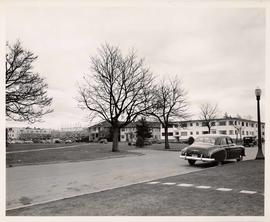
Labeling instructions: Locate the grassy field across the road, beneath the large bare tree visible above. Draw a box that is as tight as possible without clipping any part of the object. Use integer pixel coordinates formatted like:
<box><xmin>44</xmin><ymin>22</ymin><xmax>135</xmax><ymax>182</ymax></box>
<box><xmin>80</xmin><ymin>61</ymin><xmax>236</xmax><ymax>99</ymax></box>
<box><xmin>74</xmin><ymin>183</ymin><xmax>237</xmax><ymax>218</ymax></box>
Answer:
<box><xmin>6</xmin><ymin>143</ymin><xmax>186</xmax><ymax>167</ymax></box>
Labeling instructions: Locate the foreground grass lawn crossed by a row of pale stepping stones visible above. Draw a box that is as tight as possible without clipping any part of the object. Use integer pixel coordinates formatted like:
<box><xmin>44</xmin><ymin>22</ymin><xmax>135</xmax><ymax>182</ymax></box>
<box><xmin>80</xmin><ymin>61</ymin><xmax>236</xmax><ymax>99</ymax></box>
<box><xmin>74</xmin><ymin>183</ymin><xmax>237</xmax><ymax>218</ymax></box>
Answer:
<box><xmin>7</xmin><ymin>160</ymin><xmax>264</xmax><ymax>216</ymax></box>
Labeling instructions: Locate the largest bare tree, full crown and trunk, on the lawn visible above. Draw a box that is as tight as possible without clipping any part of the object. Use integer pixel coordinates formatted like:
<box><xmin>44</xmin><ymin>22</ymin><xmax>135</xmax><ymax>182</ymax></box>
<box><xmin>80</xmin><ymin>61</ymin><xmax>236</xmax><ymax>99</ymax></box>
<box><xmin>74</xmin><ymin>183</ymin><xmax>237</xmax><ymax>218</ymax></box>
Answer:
<box><xmin>78</xmin><ymin>44</ymin><xmax>153</xmax><ymax>152</ymax></box>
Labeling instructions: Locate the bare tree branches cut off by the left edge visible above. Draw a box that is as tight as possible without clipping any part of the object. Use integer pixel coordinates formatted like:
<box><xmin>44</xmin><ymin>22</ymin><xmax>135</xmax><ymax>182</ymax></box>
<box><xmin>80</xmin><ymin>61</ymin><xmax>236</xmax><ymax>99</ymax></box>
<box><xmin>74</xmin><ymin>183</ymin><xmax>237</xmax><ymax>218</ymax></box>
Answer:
<box><xmin>6</xmin><ymin>41</ymin><xmax>53</xmax><ymax>123</ymax></box>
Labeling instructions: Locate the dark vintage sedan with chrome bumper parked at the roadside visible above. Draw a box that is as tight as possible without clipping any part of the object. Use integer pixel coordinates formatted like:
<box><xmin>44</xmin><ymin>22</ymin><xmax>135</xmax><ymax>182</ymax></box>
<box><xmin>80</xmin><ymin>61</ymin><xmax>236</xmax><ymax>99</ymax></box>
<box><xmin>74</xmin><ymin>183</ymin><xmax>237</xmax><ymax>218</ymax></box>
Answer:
<box><xmin>180</xmin><ymin>134</ymin><xmax>245</xmax><ymax>165</ymax></box>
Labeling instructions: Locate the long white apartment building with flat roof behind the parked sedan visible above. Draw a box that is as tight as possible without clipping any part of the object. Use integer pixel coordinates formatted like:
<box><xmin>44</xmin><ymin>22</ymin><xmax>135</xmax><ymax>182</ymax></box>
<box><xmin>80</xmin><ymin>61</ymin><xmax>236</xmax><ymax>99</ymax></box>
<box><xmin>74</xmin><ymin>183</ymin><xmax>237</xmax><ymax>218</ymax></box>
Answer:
<box><xmin>161</xmin><ymin>117</ymin><xmax>265</xmax><ymax>141</ymax></box>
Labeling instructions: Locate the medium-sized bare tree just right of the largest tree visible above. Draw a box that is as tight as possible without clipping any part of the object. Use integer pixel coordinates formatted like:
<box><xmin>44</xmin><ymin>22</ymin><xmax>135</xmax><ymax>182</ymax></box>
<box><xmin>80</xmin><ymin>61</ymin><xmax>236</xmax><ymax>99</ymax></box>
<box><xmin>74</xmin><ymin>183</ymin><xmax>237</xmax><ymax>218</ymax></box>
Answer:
<box><xmin>148</xmin><ymin>77</ymin><xmax>189</xmax><ymax>149</ymax></box>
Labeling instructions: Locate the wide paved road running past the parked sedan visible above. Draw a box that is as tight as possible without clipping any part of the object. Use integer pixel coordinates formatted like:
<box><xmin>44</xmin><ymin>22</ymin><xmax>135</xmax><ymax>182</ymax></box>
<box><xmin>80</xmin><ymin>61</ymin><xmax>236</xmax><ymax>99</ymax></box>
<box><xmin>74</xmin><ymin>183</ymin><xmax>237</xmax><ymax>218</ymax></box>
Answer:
<box><xmin>6</xmin><ymin>148</ymin><xmax>262</xmax><ymax>209</ymax></box>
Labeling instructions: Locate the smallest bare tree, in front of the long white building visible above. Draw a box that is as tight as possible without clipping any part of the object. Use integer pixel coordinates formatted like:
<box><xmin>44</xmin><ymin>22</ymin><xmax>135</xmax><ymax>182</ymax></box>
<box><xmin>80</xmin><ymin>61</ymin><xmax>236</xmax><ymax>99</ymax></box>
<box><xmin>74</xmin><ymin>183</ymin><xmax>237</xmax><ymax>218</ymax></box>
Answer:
<box><xmin>200</xmin><ymin>103</ymin><xmax>219</xmax><ymax>133</ymax></box>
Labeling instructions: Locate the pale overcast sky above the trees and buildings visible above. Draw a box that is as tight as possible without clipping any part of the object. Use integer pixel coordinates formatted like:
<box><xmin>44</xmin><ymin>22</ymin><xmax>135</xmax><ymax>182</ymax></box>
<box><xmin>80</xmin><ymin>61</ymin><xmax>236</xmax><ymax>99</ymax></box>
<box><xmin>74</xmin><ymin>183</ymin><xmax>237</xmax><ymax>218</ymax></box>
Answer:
<box><xmin>6</xmin><ymin>3</ymin><xmax>265</xmax><ymax>128</ymax></box>
